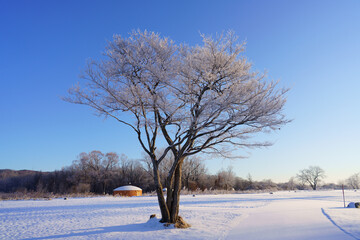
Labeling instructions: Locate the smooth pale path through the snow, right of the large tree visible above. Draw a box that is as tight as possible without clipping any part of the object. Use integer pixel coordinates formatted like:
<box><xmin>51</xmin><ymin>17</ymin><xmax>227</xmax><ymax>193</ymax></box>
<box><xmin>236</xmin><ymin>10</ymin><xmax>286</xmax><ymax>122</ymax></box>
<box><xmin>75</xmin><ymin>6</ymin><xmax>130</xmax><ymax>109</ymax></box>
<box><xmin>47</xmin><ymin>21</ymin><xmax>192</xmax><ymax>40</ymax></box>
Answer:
<box><xmin>227</xmin><ymin>199</ymin><xmax>359</xmax><ymax>240</ymax></box>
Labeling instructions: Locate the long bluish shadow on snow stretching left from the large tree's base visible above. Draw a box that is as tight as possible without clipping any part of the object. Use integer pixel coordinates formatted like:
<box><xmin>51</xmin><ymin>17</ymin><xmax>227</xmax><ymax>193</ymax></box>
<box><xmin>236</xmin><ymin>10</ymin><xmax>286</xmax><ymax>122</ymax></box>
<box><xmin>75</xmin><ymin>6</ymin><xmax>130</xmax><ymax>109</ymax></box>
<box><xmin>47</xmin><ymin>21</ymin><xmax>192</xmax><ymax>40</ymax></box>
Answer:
<box><xmin>23</xmin><ymin>219</ymin><xmax>165</xmax><ymax>240</ymax></box>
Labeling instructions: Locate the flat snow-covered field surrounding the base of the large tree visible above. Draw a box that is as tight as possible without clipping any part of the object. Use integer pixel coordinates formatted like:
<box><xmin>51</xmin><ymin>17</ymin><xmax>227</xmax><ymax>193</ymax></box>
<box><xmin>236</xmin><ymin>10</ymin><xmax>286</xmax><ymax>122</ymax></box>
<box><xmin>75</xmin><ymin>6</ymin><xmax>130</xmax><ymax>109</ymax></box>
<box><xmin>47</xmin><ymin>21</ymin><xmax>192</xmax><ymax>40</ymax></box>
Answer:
<box><xmin>0</xmin><ymin>191</ymin><xmax>360</xmax><ymax>240</ymax></box>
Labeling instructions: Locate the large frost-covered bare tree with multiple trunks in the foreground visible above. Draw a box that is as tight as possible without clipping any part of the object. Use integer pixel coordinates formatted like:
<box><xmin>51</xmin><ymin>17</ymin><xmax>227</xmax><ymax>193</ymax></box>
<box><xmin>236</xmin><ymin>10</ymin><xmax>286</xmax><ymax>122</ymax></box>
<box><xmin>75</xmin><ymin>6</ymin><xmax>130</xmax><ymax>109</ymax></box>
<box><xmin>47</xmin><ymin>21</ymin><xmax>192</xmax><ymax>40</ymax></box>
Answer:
<box><xmin>65</xmin><ymin>31</ymin><xmax>289</xmax><ymax>226</ymax></box>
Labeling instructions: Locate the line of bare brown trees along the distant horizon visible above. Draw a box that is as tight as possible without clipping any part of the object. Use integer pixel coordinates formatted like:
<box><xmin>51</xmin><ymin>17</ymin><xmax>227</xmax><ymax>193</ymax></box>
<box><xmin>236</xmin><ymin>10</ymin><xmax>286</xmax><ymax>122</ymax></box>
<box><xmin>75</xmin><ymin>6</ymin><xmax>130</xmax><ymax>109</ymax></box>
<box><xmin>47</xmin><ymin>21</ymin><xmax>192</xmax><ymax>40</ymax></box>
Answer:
<box><xmin>0</xmin><ymin>151</ymin><xmax>360</xmax><ymax>194</ymax></box>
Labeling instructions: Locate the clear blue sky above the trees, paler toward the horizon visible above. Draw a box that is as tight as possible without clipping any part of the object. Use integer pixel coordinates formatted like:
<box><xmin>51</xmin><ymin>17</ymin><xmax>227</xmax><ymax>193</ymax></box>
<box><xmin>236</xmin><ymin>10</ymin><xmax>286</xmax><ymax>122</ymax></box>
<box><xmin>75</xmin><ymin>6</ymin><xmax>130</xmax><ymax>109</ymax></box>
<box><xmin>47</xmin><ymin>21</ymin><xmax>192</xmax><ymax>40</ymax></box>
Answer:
<box><xmin>0</xmin><ymin>0</ymin><xmax>360</xmax><ymax>182</ymax></box>
